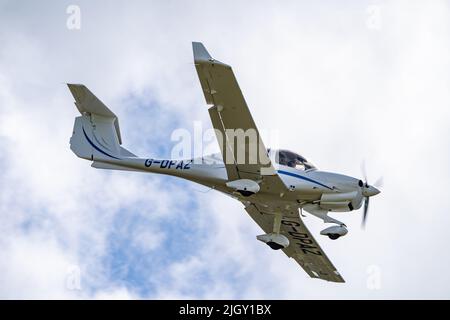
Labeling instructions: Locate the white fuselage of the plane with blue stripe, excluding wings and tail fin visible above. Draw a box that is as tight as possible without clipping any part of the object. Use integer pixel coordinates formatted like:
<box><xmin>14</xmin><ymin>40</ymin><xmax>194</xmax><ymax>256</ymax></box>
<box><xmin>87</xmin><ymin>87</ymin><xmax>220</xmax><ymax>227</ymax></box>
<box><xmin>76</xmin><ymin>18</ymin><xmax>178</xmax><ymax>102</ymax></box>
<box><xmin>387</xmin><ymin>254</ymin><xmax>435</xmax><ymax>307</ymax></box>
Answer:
<box><xmin>96</xmin><ymin>154</ymin><xmax>362</xmax><ymax>211</ymax></box>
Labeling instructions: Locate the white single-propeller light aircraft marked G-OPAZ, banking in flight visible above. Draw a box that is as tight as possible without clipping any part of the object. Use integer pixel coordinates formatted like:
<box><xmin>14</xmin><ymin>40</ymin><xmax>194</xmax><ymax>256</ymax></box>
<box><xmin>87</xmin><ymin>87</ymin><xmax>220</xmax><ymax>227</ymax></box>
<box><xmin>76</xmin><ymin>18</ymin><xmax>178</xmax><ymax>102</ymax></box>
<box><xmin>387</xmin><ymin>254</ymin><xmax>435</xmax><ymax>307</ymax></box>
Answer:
<box><xmin>68</xmin><ymin>42</ymin><xmax>380</xmax><ymax>282</ymax></box>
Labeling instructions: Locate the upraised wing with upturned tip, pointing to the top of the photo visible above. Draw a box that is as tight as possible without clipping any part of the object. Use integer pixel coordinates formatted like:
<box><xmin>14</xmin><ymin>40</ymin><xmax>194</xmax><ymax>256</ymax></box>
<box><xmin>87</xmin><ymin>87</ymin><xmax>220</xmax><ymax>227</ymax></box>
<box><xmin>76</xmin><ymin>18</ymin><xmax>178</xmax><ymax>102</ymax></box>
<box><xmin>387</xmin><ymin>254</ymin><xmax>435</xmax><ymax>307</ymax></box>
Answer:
<box><xmin>192</xmin><ymin>42</ymin><xmax>276</xmax><ymax>182</ymax></box>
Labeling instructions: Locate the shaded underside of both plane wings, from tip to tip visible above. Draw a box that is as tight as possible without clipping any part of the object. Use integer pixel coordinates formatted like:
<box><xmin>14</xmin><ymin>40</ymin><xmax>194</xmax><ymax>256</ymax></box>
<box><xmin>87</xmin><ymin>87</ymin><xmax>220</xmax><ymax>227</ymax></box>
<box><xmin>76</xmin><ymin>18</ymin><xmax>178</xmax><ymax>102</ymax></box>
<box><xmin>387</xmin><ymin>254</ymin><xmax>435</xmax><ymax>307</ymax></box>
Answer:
<box><xmin>192</xmin><ymin>42</ymin><xmax>344</xmax><ymax>282</ymax></box>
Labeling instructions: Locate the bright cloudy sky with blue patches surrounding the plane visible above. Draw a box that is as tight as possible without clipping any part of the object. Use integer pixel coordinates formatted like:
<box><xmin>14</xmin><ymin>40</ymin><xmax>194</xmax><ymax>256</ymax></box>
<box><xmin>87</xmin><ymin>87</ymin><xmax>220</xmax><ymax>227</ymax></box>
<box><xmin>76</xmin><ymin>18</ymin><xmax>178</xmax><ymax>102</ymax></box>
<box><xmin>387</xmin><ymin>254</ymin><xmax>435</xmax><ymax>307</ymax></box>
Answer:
<box><xmin>0</xmin><ymin>0</ymin><xmax>450</xmax><ymax>299</ymax></box>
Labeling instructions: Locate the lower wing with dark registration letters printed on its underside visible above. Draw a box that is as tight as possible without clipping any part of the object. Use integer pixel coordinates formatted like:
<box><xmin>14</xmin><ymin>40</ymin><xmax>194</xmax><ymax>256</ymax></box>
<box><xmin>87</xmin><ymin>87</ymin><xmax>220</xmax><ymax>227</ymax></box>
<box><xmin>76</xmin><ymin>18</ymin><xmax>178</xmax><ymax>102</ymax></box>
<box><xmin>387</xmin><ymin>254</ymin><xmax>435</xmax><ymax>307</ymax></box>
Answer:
<box><xmin>245</xmin><ymin>203</ymin><xmax>345</xmax><ymax>282</ymax></box>
